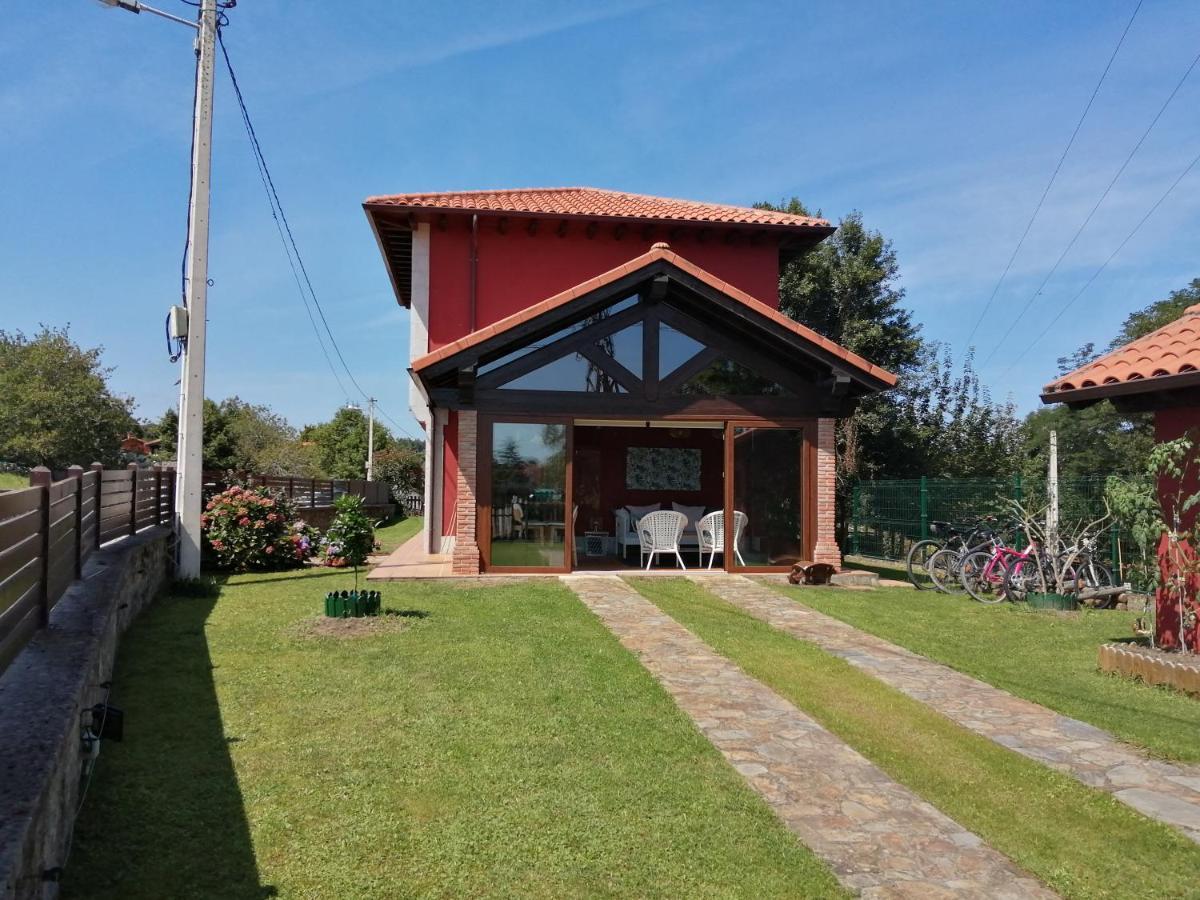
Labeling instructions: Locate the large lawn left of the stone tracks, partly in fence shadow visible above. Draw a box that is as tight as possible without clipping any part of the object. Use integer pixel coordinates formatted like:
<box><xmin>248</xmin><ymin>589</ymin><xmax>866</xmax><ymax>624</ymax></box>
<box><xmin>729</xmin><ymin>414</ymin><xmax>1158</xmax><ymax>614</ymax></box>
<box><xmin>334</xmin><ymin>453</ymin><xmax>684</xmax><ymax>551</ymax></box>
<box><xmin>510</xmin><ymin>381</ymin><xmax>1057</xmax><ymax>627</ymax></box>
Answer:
<box><xmin>65</xmin><ymin>569</ymin><xmax>841</xmax><ymax>899</ymax></box>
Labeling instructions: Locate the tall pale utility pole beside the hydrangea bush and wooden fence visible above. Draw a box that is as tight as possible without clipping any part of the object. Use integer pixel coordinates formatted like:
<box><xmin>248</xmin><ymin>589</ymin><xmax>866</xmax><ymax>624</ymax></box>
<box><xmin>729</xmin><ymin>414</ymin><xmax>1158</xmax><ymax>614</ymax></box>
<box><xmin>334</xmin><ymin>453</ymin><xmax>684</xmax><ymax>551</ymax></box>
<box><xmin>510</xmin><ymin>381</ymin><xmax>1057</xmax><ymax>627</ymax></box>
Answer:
<box><xmin>175</xmin><ymin>0</ymin><xmax>217</xmax><ymax>578</ymax></box>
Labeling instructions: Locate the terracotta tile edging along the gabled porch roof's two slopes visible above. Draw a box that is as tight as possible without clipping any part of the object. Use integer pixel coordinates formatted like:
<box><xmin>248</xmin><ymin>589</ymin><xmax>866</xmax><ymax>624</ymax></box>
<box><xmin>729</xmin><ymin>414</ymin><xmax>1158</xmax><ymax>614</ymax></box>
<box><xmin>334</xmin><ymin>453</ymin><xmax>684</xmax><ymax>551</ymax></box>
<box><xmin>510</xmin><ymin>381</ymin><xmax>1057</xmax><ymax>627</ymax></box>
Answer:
<box><xmin>413</xmin><ymin>242</ymin><xmax>896</xmax><ymax>386</ymax></box>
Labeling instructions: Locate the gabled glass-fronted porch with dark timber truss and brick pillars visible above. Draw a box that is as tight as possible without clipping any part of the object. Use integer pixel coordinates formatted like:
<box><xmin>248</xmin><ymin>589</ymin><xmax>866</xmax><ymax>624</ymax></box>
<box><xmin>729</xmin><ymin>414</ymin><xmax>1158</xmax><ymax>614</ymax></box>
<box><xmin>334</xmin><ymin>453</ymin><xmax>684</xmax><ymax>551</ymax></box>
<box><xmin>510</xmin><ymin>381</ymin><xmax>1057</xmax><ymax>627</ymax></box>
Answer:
<box><xmin>412</xmin><ymin>245</ymin><xmax>895</xmax><ymax>574</ymax></box>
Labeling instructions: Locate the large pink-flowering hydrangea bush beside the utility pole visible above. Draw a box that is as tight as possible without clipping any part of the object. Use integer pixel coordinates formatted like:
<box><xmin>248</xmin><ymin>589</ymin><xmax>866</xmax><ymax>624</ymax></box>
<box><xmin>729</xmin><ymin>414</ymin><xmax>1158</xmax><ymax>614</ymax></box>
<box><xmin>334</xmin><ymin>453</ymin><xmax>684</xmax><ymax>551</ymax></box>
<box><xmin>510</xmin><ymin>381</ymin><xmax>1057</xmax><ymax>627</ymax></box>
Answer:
<box><xmin>200</xmin><ymin>486</ymin><xmax>318</xmax><ymax>572</ymax></box>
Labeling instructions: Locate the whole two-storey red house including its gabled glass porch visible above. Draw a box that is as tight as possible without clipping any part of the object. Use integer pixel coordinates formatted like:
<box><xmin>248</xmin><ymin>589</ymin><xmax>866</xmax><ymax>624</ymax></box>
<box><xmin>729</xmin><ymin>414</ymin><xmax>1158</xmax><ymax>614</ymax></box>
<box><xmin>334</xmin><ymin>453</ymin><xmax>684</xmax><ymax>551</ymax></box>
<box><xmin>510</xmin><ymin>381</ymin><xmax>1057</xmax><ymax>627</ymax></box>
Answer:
<box><xmin>364</xmin><ymin>187</ymin><xmax>895</xmax><ymax>574</ymax></box>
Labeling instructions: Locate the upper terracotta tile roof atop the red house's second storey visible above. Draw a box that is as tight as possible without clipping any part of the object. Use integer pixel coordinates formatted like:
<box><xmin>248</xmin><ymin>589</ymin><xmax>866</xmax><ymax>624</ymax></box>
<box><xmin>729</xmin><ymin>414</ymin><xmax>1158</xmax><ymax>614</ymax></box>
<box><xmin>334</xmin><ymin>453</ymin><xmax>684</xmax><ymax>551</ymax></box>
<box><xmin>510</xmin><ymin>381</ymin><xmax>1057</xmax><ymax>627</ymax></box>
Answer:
<box><xmin>365</xmin><ymin>187</ymin><xmax>832</xmax><ymax>229</ymax></box>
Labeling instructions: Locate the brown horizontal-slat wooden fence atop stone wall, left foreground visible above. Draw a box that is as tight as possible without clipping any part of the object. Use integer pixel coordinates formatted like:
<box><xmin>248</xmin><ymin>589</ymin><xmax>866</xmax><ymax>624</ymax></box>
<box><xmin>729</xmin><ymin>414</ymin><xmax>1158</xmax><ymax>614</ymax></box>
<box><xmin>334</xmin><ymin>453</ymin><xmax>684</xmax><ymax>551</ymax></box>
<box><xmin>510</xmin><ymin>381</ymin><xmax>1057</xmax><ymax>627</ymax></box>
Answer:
<box><xmin>0</xmin><ymin>462</ymin><xmax>175</xmax><ymax>672</ymax></box>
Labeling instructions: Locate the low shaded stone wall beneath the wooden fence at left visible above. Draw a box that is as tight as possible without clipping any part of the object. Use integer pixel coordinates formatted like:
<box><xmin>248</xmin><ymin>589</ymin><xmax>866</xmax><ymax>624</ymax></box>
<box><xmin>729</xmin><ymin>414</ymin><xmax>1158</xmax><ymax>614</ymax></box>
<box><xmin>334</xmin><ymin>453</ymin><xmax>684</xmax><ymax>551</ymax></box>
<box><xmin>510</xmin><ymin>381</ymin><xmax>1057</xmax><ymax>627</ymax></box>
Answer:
<box><xmin>0</xmin><ymin>527</ymin><xmax>172</xmax><ymax>900</ymax></box>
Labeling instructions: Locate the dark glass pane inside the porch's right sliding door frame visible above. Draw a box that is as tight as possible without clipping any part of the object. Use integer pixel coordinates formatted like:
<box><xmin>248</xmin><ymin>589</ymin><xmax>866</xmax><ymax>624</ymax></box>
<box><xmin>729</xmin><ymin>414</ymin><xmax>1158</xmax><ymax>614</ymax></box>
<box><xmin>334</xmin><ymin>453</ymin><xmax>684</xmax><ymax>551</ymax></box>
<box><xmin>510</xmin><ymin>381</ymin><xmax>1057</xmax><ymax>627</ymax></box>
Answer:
<box><xmin>733</xmin><ymin>427</ymin><xmax>804</xmax><ymax>566</ymax></box>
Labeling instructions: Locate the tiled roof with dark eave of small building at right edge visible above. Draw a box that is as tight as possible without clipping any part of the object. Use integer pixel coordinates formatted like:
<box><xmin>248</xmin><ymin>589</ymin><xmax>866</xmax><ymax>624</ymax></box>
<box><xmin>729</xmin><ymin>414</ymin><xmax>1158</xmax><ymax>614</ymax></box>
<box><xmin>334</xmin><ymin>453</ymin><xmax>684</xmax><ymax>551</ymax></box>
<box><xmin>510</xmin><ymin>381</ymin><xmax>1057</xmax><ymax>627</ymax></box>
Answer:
<box><xmin>1042</xmin><ymin>304</ymin><xmax>1200</xmax><ymax>403</ymax></box>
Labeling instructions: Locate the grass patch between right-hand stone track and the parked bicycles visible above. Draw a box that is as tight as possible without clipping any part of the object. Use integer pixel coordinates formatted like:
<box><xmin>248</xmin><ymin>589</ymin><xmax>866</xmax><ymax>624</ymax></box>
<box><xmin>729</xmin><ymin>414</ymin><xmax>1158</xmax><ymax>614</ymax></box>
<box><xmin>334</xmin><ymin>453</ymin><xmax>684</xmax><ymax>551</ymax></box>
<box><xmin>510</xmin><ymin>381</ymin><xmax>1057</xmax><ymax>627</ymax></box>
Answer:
<box><xmin>772</xmin><ymin>583</ymin><xmax>1200</xmax><ymax>762</ymax></box>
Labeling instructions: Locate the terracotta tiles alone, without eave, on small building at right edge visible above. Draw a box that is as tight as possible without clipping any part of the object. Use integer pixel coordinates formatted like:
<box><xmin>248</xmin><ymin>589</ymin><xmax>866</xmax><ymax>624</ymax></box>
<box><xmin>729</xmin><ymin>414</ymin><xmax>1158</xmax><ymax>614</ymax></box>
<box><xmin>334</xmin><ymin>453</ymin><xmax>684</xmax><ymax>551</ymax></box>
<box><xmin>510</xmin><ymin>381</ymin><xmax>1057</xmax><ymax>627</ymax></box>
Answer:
<box><xmin>1042</xmin><ymin>304</ymin><xmax>1200</xmax><ymax>395</ymax></box>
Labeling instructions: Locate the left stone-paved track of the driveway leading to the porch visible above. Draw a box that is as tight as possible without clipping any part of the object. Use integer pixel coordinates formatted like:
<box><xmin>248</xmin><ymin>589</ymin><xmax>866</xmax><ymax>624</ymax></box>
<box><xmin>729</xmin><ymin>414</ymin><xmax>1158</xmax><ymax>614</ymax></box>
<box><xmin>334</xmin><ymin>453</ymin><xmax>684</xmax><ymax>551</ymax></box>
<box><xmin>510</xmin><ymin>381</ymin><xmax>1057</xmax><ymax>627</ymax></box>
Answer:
<box><xmin>563</xmin><ymin>576</ymin><xmax>1055</xmax><ymax>900</ymax></box>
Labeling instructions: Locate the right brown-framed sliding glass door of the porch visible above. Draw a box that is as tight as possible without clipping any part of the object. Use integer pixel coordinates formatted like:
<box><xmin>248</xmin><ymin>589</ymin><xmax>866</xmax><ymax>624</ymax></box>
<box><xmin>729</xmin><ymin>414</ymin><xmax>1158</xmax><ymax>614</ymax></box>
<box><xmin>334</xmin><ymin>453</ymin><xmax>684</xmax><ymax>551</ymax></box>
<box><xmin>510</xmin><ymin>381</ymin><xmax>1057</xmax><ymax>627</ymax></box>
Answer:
<box><xmin>725</xmin><ymin>424</ymin><xmax>812</xmax><ymax>570</ymax></box>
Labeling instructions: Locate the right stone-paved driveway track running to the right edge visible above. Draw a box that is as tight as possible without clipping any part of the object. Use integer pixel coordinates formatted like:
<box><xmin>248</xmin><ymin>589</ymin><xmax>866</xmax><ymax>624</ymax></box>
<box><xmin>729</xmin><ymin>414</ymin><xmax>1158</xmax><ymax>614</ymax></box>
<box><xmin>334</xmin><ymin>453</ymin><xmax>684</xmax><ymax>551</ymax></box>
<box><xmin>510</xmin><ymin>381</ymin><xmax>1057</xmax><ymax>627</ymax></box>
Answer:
<box><xmin>690</xmin><ymin>575</ymin><xmax>1200</xmax><ymax>844</ymax></box>
